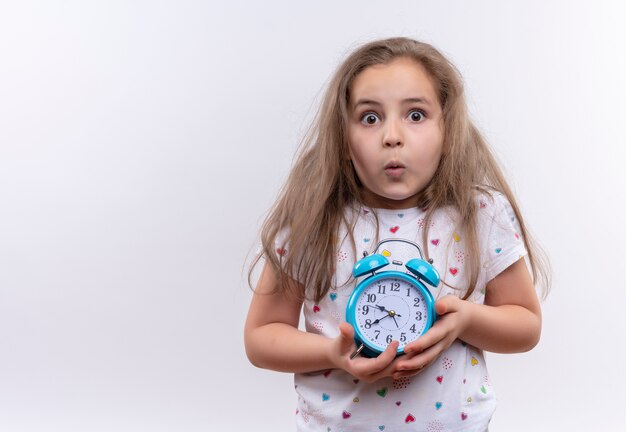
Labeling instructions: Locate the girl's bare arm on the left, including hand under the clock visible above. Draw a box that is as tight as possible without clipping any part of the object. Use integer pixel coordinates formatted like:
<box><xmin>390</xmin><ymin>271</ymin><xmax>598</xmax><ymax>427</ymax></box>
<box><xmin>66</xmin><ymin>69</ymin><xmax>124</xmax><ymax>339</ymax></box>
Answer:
<box><xmin>244</xmin><ymin>264</ymin><xmax>397</xmax><ymax>381</ymax></box>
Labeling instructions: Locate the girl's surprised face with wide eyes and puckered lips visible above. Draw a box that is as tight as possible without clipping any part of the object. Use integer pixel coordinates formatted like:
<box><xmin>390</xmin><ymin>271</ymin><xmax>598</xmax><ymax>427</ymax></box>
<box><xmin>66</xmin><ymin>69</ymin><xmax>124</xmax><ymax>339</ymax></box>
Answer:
<box><xmin>348</xmin><ymin>57</ymin><xmax>443</xmax><ymax>209</ymax></box>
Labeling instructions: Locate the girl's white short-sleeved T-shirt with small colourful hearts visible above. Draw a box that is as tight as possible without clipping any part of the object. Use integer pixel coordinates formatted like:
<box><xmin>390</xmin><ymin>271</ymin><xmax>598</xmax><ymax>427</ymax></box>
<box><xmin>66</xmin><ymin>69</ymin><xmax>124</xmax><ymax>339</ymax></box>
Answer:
<box><xmin>280</xmin><ymin>193</ymin><xmax>526</xmax><ymax>432</ymax></box>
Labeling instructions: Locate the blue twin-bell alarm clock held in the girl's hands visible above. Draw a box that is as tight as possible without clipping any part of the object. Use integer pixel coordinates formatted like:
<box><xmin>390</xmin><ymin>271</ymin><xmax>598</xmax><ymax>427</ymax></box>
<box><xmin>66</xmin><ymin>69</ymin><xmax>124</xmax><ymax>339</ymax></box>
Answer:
<box><xmin>346</xmin><ymin>239</ymin><xmax>440</xmax><ymax>358</ymax></box>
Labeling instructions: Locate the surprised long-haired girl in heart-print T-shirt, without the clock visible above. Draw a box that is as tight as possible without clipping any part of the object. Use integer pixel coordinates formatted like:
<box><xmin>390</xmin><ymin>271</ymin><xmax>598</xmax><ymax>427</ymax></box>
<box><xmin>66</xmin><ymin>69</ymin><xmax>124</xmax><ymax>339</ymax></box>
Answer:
<box><xmin>245</xmin><ymin>38</ymin><xmax>549</xmax><ymax>432</ymax></box>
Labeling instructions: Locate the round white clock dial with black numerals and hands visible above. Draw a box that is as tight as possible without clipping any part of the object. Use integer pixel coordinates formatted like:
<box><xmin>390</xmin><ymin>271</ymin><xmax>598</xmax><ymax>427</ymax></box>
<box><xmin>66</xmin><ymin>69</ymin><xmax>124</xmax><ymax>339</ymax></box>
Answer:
<box><xmin>354</xmin><ymin>276</ymin><xmax>432</xmax><ymax>351</ymax></box>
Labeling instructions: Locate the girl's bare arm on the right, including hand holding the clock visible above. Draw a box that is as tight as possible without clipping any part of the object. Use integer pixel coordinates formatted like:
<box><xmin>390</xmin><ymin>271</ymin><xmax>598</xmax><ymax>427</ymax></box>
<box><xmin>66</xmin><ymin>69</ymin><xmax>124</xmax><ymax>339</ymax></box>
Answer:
<box><xmin>394</xmin><ymin>259</ymin><xmax>541</xmax><ymax>378</ymax></box>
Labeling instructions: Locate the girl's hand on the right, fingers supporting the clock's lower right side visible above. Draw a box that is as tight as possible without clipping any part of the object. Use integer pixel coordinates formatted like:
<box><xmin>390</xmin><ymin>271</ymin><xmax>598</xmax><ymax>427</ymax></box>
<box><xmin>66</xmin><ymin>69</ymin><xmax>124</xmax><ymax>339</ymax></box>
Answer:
<box><xmin>393</xmin><ymin>295</ymin><xmax>469</xmax><ymax>379</ymax></box>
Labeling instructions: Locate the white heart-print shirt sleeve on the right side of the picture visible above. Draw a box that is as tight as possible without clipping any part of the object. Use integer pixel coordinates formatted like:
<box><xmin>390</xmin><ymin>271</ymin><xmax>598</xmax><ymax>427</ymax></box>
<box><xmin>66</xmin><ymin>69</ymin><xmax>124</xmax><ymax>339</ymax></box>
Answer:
<box><xmin>479</xmin><ymin>192</ymin><xmax>528</xmax><ymax>282</ymax></box>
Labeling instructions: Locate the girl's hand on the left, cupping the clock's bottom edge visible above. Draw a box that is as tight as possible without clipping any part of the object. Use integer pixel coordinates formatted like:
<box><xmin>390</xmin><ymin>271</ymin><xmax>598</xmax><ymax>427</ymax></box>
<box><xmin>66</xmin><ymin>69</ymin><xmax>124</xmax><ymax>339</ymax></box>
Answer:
<box><xmin>330</xmin><ymin>322</ymin><xmax>398</xmax><ymax>383</ymax></box>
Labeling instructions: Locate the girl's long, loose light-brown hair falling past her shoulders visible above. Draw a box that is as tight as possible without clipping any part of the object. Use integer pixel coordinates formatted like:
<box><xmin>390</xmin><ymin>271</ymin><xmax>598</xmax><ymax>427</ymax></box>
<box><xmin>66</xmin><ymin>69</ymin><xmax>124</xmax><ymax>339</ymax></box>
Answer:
<box><xmin>249</xmin><ymin>38</ymin><xmax>550</xmax><ymax>301</ymax></box>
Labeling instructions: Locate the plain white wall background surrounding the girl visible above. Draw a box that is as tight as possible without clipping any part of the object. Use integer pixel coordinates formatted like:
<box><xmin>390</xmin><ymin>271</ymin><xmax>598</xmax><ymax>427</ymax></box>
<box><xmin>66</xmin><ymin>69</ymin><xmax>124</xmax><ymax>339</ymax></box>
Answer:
<box><xmin>0</xmin><ymin>0</ymin><xmax>626</xmax><ymax>432</ymax></box>
